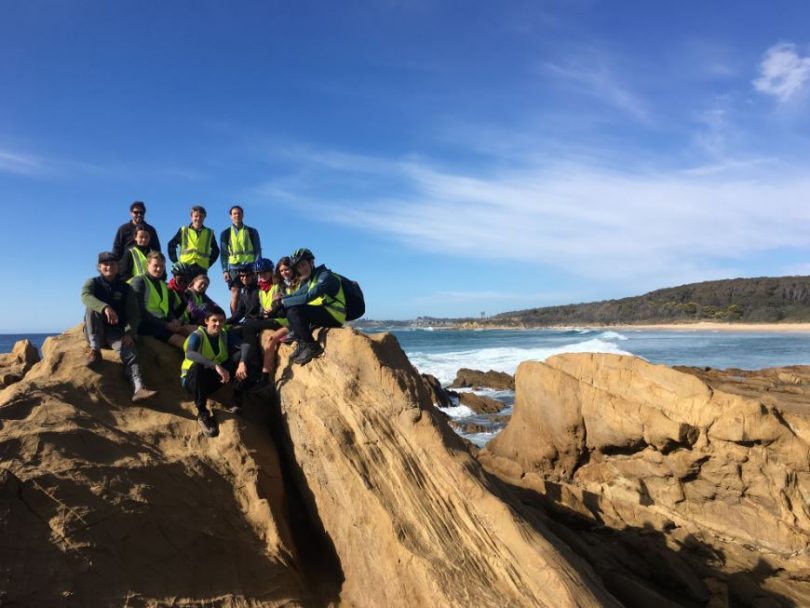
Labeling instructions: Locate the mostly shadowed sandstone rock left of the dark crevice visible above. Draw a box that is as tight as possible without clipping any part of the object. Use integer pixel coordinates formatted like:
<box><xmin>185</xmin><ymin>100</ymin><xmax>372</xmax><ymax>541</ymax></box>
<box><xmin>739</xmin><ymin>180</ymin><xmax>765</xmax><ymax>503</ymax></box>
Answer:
<box><xmin>0</xmin><ymin>330</ymin><xmax>312</xmax><ymax>606</ymax></box>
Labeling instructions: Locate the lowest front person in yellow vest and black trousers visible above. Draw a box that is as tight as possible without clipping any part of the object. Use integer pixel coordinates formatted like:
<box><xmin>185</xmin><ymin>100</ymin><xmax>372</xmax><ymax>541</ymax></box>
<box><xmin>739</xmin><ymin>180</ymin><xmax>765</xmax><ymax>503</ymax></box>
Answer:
<box><xmin>180</xmin><ymin>306</ymin><xmax>244</xmax><ymax>437</ymax></box>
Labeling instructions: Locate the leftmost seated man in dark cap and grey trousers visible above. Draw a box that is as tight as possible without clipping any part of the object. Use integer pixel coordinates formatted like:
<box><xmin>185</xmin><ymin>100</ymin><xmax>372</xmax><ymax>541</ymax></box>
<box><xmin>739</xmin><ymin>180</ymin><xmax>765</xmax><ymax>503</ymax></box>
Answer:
<box><xmin>82</xmin><ymin>251</ymin><xmax>157</xmax><ymax>402</ymax></box>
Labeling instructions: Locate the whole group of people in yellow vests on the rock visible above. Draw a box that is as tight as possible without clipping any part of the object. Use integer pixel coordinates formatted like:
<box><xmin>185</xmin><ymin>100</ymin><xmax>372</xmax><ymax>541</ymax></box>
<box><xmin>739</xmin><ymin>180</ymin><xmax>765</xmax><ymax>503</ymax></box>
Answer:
<box><xmin>82</xmin><ymin>201</ymin><xmax>346</xmax><ymax>436</ymax></box>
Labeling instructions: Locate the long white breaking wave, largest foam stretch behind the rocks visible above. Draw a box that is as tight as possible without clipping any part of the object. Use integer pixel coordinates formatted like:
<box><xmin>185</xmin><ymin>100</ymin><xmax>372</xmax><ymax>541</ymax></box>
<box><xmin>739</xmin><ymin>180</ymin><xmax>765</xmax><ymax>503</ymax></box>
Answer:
<box><xmin>407</xmin><ymin>338</ymin><xmax>631</xmax><ymax>384</ymax></box>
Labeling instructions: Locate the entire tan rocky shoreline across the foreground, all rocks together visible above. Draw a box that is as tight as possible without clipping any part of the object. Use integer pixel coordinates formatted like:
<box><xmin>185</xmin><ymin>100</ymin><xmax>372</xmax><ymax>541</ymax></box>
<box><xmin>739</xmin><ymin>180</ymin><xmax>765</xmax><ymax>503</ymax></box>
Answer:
<box><xmin>0</xmin><ymin>329</ymin><xmax>810</xmax><ymax>607</ymax></box>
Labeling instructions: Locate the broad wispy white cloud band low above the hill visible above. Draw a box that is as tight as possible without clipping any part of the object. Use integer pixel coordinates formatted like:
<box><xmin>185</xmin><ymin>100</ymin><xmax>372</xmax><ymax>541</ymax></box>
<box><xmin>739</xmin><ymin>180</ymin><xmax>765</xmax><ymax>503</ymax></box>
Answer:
<box><xmin>256</xmin><ymin>147</ymin><xmax>810</xmax><ymax>288</ymax></box>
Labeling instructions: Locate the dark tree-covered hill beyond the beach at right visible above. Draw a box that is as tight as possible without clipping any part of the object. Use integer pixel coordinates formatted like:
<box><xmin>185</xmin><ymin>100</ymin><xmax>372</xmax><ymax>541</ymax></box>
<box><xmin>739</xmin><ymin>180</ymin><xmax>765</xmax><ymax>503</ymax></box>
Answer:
<box><xmin>488</xmin><ymin>276</ymin><xmax>810</xmax><ymax>326</ymax></box>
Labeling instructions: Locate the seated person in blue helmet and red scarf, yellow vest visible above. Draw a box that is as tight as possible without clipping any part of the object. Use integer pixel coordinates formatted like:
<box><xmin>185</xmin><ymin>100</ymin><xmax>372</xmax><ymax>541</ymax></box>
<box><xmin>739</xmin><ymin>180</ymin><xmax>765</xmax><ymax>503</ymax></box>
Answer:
<box><xmin>236</xmin><ymin>258</ymin><xmax>289</xmax><ymax>390</ymax></box>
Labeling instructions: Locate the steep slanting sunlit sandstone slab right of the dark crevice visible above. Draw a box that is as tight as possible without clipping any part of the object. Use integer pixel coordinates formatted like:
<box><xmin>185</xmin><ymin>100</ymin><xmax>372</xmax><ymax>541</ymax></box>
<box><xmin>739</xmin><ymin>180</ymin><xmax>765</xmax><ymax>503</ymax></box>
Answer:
<box><xmin>277</xmin><ymin>329</ymin><xmax>614</xmax><ymax>607</ymax></box>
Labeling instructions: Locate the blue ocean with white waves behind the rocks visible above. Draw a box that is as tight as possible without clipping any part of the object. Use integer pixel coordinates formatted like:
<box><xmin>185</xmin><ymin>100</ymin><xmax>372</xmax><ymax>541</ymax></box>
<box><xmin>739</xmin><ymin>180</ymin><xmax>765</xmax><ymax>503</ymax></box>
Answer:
<box><xmin>0</xmin><ymin>328</ymin><xmax>810</xmax><ymax>446</ymax></box>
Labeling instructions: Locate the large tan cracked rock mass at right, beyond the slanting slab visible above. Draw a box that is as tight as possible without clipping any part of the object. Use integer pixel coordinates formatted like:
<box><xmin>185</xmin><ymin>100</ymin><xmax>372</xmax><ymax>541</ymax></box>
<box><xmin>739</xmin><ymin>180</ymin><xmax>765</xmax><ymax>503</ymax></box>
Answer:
<box><xmin>479</xmin><ymin>354</ymin><xmax>810</xmax><ymax>606</ymax></box>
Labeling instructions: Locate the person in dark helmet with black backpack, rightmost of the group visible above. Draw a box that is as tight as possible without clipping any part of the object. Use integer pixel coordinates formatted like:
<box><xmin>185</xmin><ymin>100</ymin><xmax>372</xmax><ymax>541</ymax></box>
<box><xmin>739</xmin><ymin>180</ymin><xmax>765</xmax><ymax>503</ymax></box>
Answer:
<box><xmin>264</xmin><ymin>249</ymin><xmax>346</xmax><ymax>365</ymax></box>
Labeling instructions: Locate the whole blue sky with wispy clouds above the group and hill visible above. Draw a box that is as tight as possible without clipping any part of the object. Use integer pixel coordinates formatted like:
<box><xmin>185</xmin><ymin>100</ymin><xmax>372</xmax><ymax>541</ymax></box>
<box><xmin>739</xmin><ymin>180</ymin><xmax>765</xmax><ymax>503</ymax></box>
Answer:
<box><xmin>0</xmin><ymin>0</ymin><xmax>810</xmax><ymax>332</ymax></box>
